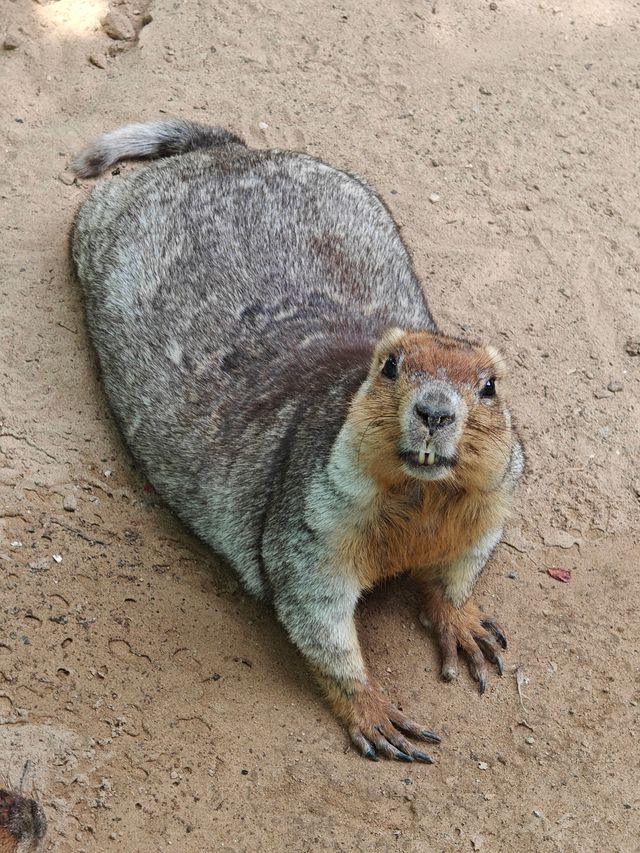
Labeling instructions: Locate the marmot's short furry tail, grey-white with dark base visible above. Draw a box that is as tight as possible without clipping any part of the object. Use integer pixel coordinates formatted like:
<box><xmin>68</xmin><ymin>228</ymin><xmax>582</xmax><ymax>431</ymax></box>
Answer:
<box><xmin>71</xmin><ymin>119</ymin><xmax>244</xmax><ymax>178</ymax></box>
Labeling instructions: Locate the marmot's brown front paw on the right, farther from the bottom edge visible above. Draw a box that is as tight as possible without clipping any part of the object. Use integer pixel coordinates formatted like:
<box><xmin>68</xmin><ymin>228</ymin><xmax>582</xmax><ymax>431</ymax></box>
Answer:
<box><xmin>420</xmin><ymin>601</ymin><xmax>507</xmax><ymax>693</ymax></box>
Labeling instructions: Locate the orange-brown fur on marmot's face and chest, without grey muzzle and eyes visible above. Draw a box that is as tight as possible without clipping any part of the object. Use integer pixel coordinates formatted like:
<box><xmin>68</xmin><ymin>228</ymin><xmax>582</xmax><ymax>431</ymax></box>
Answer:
<box><xmin>334</xmin><ymin>330</ymin><xmax>516</xmax><ymax>587</ymax></box>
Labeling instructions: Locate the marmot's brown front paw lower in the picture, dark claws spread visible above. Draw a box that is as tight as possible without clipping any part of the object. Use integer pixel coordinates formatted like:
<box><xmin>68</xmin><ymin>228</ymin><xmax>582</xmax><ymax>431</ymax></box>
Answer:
<box><xmin>348</xmin><ymin>689</ymin><xmax>440</xmax><ymax>764</ymax></box>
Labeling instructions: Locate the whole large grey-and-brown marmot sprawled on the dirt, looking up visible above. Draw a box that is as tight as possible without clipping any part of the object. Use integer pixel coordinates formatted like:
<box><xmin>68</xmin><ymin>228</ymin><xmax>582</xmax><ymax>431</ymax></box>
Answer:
<box><xmin>72</xmin><ymin>120</ymin><xmax>523</xmax><ymax>762</ymax></box>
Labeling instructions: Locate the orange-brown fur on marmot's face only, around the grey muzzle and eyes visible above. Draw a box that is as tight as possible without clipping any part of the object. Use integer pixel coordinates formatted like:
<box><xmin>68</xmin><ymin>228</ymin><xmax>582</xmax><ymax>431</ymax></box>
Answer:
<box><xmin>349</xmin><ymin>329</ymin><xmax>513</xmax><ymax>491</ymax></box>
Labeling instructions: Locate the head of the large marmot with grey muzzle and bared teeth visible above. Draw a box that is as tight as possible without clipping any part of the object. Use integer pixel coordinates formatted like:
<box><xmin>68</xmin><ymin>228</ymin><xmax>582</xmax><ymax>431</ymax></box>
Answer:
<box><xmin>349</xmin><ymin>329</ymin><xmax>515</xmax><ymax>490</ymax></box>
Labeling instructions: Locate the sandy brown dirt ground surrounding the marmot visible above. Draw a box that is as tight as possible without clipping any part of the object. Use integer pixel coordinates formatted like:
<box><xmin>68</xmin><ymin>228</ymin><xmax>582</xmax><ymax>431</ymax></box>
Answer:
<box><xmin>0</xmin><ymin>0</ymin><xmax>640</xmax><ymax>853</ymax></box>
